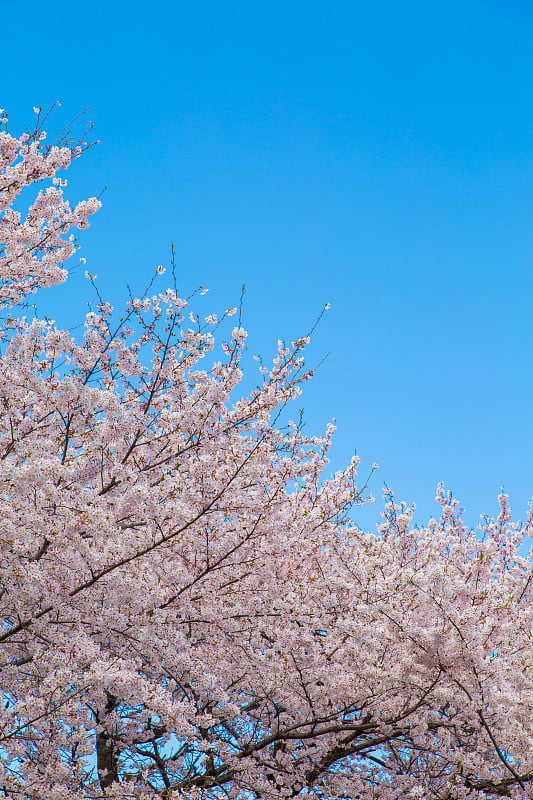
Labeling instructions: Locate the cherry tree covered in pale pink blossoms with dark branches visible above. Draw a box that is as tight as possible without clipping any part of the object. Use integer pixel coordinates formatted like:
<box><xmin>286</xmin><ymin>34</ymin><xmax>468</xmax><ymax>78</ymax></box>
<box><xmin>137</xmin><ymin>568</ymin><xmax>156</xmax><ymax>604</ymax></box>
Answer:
<box><xmin>0</xmin><ymin>108</ymin><xmax>533</xmax><ymax>800</ymax></box>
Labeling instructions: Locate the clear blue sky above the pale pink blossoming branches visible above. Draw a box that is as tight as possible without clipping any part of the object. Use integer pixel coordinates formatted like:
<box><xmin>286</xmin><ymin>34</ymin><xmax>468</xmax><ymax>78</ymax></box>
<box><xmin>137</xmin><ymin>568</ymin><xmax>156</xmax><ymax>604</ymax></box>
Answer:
<box><xmin>0</xmin><ymin>0</ymin><xmax>533</xmax><ymax>526</ymax></box>
